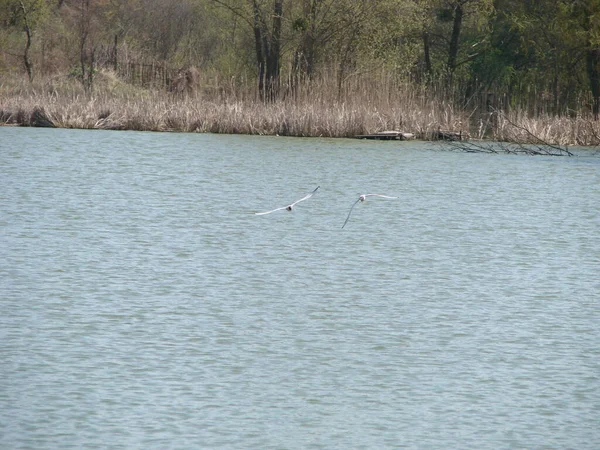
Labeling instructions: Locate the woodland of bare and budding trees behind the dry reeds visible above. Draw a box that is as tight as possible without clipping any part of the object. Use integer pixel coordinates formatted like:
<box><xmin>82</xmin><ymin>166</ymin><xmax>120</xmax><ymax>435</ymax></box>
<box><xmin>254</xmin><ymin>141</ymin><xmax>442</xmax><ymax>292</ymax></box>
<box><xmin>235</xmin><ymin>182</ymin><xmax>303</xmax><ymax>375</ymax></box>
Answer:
<box><xmin>0</xmin><ymin>0</ymin><xmax>600</xmax><ymax>117</ymax></box>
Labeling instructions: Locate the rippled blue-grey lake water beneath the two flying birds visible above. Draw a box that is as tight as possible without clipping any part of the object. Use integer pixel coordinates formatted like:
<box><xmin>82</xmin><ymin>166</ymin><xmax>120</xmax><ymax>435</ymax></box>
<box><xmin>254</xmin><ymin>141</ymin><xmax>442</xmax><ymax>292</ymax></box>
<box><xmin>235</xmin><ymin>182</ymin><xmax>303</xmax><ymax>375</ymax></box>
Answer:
<box><xmin>0</xmin><ymin>127</ymin><xmax>600</xmax><ymax>449</ymax></box>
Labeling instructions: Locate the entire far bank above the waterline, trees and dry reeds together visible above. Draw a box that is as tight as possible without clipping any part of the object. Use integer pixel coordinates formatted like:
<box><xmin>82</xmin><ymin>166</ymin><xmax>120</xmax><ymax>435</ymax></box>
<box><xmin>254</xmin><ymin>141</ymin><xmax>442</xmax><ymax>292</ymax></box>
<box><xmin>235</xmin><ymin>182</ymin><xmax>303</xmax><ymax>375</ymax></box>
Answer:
<box><xmin>0</xmin><ymin>0</ymin><xmax>600</xmax><ymax>148</ymax></box>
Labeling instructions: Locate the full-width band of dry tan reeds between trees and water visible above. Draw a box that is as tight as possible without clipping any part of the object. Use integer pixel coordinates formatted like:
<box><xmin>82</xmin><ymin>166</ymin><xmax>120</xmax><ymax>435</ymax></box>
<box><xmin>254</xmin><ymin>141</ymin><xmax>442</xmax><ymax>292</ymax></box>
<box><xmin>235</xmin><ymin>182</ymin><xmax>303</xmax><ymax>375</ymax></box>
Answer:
<box><xmin>0</xmin><ymin>72</ymin><xmax>600</xmax><ymax>146</ymax></box>
